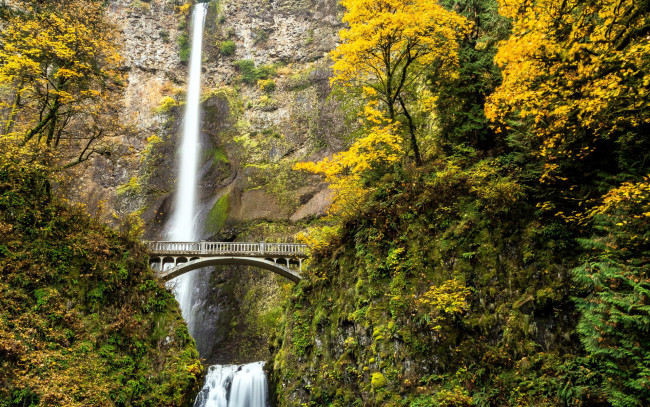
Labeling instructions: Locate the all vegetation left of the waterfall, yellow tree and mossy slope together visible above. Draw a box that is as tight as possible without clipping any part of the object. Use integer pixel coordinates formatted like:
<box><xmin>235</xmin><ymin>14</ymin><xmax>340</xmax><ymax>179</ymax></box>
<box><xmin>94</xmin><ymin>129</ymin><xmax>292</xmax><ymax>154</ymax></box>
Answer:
<box><xmin>0</xmin><ymin>0</ymin><xmax>202</xmax><ymax>407</ymax></box>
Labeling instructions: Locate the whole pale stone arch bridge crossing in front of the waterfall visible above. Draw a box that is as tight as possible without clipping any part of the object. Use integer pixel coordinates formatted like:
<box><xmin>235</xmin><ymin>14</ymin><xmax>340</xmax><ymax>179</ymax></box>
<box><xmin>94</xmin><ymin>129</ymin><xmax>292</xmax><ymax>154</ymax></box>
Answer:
<box><xmin>143</xmin><ymin>242</ymin><xmax>307</xmax><ymax>283</ymax></box>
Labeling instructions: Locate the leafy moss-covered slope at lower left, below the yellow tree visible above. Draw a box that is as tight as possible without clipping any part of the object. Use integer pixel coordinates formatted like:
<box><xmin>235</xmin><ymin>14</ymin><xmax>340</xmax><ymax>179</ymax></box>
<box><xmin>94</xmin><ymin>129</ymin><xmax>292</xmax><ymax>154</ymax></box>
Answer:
<box><xmin>0</xmin><ymin>168</ymin><xmax>202</xmax><ymax>406</ymax></box>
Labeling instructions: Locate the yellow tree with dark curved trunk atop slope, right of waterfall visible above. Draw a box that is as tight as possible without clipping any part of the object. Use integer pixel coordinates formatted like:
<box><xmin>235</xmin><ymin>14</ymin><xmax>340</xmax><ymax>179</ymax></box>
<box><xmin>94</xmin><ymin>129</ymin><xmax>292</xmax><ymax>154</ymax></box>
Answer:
<box><xmin>331</xmin><ymin>0</ymin><xmax>467</xmax><ymax>165</ymax></box>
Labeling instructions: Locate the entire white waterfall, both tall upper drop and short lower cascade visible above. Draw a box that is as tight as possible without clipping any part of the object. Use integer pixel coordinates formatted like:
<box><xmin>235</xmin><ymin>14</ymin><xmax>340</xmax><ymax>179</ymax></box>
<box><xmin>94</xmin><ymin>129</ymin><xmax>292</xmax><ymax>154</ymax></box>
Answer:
<box><xmin>167</xmin><ymin>3</ymin><xmax>267</xmax><ymax>407</ymax></box>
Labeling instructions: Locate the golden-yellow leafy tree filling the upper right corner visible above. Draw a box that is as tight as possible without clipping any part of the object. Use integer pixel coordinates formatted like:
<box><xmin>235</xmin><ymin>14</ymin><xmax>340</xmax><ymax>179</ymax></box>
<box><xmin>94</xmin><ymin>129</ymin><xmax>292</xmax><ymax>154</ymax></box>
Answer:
<box><xmin>486</xmin><ymin>0</ymin><xmax>650</xmax><ymax>191</ymax></box>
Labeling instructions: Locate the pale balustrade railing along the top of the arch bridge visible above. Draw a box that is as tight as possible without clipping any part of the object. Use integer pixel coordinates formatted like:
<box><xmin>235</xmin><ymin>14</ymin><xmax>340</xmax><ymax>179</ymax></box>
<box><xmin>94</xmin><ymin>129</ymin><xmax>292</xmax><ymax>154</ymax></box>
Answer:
<box><xmin>143</xmin><ymin>241</ymin><xmax>307</xmax><ymax>257</ymax></box>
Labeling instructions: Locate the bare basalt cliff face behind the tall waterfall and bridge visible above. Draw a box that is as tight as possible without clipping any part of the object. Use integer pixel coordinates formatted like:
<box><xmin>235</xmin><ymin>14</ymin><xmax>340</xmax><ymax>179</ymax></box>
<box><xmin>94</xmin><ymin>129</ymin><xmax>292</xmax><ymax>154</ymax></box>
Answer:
<box><xmin>70</xmin><ymin>0</ymin><xmax>349</xmax><ymax>363</ymax></box>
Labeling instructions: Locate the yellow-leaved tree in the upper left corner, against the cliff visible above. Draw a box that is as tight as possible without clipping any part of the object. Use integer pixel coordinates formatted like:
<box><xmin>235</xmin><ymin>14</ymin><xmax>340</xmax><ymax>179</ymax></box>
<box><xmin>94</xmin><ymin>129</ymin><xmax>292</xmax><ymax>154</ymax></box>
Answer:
<box><xmin>0</xmin><ymin>0</ymin><xmax>122</xmax><ymax>165</ymax></box>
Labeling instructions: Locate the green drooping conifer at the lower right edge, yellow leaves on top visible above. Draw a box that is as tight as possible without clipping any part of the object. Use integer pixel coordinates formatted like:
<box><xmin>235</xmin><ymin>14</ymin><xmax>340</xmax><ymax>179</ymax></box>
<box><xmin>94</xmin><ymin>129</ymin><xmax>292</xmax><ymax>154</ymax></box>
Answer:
<box><xmin>573</xmin><ymin>178</ymin><xmax>650</xmax><ymax>407</ymax></box>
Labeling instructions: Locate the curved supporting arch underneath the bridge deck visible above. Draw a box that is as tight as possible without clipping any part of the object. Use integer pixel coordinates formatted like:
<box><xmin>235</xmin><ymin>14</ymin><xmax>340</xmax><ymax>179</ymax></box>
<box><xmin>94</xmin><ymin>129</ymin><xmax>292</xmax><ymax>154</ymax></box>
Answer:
<box><xmin>156</xmin><ymin>256</ymin><xmax>302</xmax><ymax>283</ymax></box>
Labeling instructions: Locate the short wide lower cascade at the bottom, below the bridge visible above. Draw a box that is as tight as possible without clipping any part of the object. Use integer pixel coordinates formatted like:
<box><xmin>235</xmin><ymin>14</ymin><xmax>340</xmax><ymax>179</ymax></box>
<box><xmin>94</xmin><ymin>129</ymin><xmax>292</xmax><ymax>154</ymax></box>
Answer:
<box><xmin>194</xmin><ymin>362</ymin><xmax>268</xmax><ymax>407</ymax></box>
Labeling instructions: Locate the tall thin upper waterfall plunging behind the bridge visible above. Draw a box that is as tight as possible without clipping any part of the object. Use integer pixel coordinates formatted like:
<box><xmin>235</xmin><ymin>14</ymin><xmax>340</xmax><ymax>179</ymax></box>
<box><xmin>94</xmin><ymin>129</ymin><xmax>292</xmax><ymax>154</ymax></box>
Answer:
<box><xmin>168</xmin><ymin>3</ymin><xmax>208</xmax><ymax>334</ymax></box>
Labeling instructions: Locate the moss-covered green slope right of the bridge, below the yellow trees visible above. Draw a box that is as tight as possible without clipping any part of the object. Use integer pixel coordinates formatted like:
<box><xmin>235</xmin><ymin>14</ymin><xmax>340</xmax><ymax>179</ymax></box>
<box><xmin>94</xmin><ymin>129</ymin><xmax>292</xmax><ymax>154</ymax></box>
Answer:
<box><xmin>274</xmin><ymin>158</ymin><xmax>602</xmax><ymax>406</ymax></box>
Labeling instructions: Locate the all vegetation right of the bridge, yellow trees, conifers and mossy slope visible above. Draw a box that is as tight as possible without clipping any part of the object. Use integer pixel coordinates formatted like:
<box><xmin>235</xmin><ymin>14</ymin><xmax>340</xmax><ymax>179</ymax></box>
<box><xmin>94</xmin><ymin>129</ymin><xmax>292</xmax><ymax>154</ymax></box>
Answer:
<box><xmin>274</xmin><ymin>0</ymin><xmax>650</xmax><ymax>406</ymax></box>
